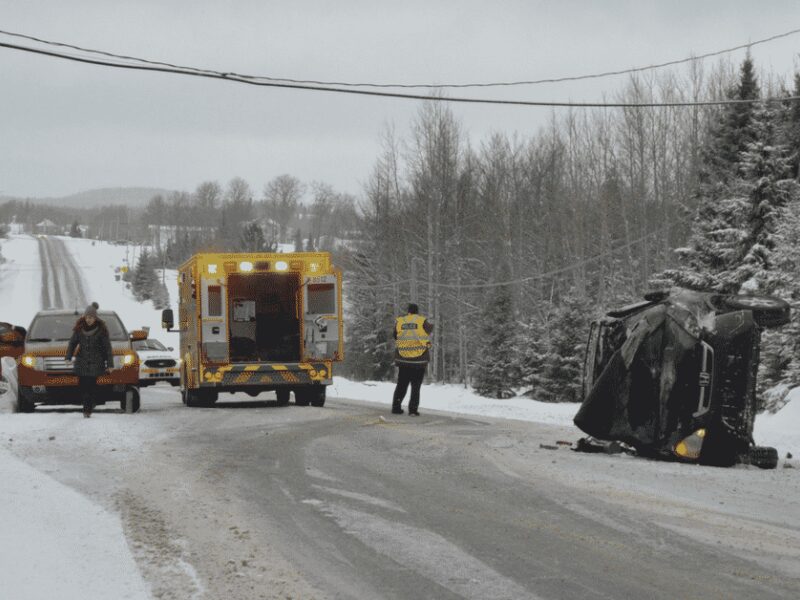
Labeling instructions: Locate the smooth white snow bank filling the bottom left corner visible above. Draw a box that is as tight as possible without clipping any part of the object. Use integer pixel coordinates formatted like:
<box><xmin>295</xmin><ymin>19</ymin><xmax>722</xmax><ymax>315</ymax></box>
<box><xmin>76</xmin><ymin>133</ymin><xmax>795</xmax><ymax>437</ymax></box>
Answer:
<box><xmin>0</xmin><ymin>446</ymin><xmax>150</xmax><ymax>600</ymax></box>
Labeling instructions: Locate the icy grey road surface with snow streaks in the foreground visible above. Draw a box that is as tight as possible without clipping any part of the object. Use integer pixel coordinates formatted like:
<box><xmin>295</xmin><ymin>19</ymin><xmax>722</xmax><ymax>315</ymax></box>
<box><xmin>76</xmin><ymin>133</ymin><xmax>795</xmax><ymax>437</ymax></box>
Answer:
<box><xmin>0</xmin><ymin>387</ymin><xmax>800</xmax><ymax>600</ymax></box>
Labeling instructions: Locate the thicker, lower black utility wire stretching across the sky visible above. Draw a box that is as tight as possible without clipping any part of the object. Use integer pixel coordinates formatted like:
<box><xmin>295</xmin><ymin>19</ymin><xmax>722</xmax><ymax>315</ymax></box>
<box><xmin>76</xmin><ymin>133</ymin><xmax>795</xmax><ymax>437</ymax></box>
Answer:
<box><xmin>0</xmin><ymin>42</ymin><xmax>800</xmax><ymax>108</ymax></box>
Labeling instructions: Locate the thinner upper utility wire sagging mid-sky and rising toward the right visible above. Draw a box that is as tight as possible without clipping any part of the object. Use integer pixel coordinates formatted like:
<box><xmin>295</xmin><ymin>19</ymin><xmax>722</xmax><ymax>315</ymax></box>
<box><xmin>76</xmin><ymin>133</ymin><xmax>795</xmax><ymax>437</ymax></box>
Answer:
<box><xmin>0</xmin><ymin>29</ymin><xmax>800</xmax><ymax>89</ymax></box>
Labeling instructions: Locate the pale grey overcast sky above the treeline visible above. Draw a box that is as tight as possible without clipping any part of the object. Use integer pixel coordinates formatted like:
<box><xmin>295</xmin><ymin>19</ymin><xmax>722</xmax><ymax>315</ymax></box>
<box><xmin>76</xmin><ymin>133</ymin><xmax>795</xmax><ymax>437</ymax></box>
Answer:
<box><xmin>0</xmin><ymin>0</ymin><xmax>800</xmax><ymax>196</ymax></box>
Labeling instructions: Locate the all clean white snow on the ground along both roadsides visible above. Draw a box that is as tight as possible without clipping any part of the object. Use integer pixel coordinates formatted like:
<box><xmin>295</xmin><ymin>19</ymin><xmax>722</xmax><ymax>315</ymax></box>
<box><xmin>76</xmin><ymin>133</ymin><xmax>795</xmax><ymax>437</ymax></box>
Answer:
<box><xmin>0</xmin><ymin>236</ymin><xmax>800</xmax><ymax>599</ymax></box>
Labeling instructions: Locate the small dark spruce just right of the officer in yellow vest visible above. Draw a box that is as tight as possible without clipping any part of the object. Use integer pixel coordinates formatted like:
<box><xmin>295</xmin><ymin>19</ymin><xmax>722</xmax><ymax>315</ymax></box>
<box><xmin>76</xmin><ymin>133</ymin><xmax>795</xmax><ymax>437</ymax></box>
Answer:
<box><xmin>473</xmin><ymin>278</ymin><xmax>519</xmax><ymax>398</ymax></box>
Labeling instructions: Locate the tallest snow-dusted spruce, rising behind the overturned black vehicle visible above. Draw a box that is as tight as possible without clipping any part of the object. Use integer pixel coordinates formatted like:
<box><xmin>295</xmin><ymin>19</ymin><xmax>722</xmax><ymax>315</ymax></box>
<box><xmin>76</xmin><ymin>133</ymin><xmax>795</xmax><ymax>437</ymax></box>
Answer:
<box><xmin>655</xmin><ymin>57</ymin><xmax>788</xmax><ymax>293</ymax></box>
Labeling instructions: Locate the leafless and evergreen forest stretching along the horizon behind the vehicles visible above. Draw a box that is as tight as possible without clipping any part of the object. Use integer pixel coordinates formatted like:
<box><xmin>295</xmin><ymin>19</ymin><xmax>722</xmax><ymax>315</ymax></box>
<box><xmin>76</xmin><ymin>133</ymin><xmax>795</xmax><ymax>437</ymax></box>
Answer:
<box><xmin>0</xmin><ymin>57</ymin><xmax>800</xmax><ymax>402</ymax></box>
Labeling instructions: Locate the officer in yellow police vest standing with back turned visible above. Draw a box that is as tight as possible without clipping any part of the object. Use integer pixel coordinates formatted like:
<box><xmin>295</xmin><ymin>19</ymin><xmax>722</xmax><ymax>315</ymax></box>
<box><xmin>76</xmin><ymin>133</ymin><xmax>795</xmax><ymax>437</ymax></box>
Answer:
<box><xmin>392</xmin><ymin>303</ymin><xmax>433</xmax><ymax>417</ymax></box>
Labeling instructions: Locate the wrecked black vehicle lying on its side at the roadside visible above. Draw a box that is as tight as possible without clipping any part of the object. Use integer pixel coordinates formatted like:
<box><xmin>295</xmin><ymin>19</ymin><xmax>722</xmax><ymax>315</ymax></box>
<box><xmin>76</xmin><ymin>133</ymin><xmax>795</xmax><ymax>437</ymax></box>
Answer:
<box><xmin>574</xmin><ymin>289</ymin><xmax>790</xmax><ymax>468</ymax></box>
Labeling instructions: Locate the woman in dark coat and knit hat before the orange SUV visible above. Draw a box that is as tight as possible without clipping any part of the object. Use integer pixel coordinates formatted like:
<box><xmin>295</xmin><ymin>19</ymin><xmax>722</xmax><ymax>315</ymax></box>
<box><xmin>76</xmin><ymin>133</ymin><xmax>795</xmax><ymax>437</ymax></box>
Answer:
<box><xmin>66</xmin><ymin>302</ymin><xmax>114</xmax><ymax>418</ymax></box>
